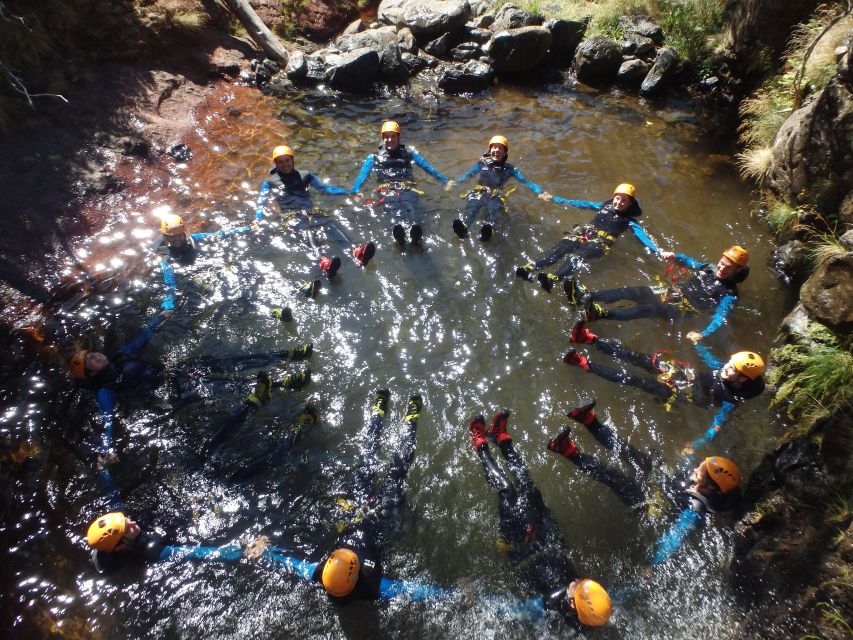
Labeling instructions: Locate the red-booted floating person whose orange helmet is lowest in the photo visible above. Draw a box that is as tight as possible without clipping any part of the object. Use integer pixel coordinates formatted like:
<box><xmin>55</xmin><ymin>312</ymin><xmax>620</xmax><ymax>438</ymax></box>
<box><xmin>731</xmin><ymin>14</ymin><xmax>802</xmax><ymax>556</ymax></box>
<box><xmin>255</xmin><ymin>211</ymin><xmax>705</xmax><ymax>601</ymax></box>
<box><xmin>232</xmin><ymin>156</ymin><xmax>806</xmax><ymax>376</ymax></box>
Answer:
<box><xmin>468</xmin><ymin>411</ymin><xmax>613</xmax><ymax>630</ymax></box>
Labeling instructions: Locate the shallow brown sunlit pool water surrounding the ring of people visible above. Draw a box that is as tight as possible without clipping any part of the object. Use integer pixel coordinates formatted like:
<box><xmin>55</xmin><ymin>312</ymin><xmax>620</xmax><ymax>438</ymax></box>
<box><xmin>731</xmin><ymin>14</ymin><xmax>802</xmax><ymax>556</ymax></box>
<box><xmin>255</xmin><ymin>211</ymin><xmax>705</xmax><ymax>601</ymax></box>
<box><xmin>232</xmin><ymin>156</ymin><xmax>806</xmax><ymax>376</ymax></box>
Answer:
<box><xmin>2</xmin><ymin>79</ymin><xmax>787</xmax><ymax>638</ymax></box>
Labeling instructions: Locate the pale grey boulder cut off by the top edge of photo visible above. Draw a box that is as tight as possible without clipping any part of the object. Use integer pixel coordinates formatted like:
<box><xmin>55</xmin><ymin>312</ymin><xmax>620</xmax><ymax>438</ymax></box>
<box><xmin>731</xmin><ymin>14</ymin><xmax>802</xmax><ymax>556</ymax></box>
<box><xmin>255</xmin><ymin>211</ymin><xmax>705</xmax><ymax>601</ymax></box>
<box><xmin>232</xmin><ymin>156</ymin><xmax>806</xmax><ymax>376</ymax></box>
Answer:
<box><xmin>378</xmin><ymin>0</ymin><xmax>471</xmax><ymax>40</ymax></box>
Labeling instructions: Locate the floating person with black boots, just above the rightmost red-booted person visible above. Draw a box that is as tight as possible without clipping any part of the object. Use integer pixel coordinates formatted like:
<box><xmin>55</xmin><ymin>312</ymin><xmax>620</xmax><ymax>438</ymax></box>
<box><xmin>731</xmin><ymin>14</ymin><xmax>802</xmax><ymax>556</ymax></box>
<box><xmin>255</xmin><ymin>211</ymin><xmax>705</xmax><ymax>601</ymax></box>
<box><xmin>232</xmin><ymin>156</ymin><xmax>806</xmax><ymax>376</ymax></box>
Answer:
<box><xmin>565</xmin><ymin>244</ymin><xmax>749</xmax><ymax>343</ymax></box>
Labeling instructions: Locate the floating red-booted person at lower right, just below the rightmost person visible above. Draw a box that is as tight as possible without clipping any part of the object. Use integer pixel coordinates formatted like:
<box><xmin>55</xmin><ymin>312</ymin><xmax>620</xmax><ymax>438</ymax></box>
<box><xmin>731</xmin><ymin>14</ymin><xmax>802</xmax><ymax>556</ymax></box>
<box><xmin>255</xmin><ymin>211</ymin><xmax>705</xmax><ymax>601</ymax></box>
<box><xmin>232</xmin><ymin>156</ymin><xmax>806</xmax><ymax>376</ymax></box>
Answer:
<box><xmin>548</xmin><ymin>401</ymin><xmax>741</xmax><ymax>564</ymax></box>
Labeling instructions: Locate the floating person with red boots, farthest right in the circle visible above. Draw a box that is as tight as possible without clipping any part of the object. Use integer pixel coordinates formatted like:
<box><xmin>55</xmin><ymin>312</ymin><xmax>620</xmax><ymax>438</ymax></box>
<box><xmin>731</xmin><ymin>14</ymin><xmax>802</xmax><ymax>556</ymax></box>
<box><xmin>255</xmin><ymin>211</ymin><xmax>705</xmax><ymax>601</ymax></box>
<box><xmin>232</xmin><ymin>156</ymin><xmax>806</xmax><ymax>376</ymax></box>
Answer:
<box><xmin>563</xmin><ymin>323</ymin><xmax>764</xmax><ymax>452</ymax></box>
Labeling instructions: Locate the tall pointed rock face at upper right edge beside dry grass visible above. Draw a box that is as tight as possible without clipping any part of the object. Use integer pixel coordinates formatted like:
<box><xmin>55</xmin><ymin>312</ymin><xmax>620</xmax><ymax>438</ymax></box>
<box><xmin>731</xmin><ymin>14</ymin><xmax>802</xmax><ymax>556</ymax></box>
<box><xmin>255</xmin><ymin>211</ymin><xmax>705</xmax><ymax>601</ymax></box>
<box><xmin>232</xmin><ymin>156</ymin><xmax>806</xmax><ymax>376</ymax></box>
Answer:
<box><xmin>766</xmin><ymin>48</ymin><xmax>853</xmax><ymax>216</ymax></box>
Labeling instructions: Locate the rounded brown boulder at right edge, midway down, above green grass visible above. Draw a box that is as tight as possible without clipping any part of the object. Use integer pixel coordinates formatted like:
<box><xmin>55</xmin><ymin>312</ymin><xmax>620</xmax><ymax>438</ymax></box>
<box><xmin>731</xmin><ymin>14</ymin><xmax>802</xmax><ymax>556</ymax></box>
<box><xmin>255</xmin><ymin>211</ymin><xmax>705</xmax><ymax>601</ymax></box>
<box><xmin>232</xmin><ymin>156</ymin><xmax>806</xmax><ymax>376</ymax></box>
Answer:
<box><xmin>800</xmin><ymin>252</ymin><xmax>853</xmax><ymax>333</ymax></box>
